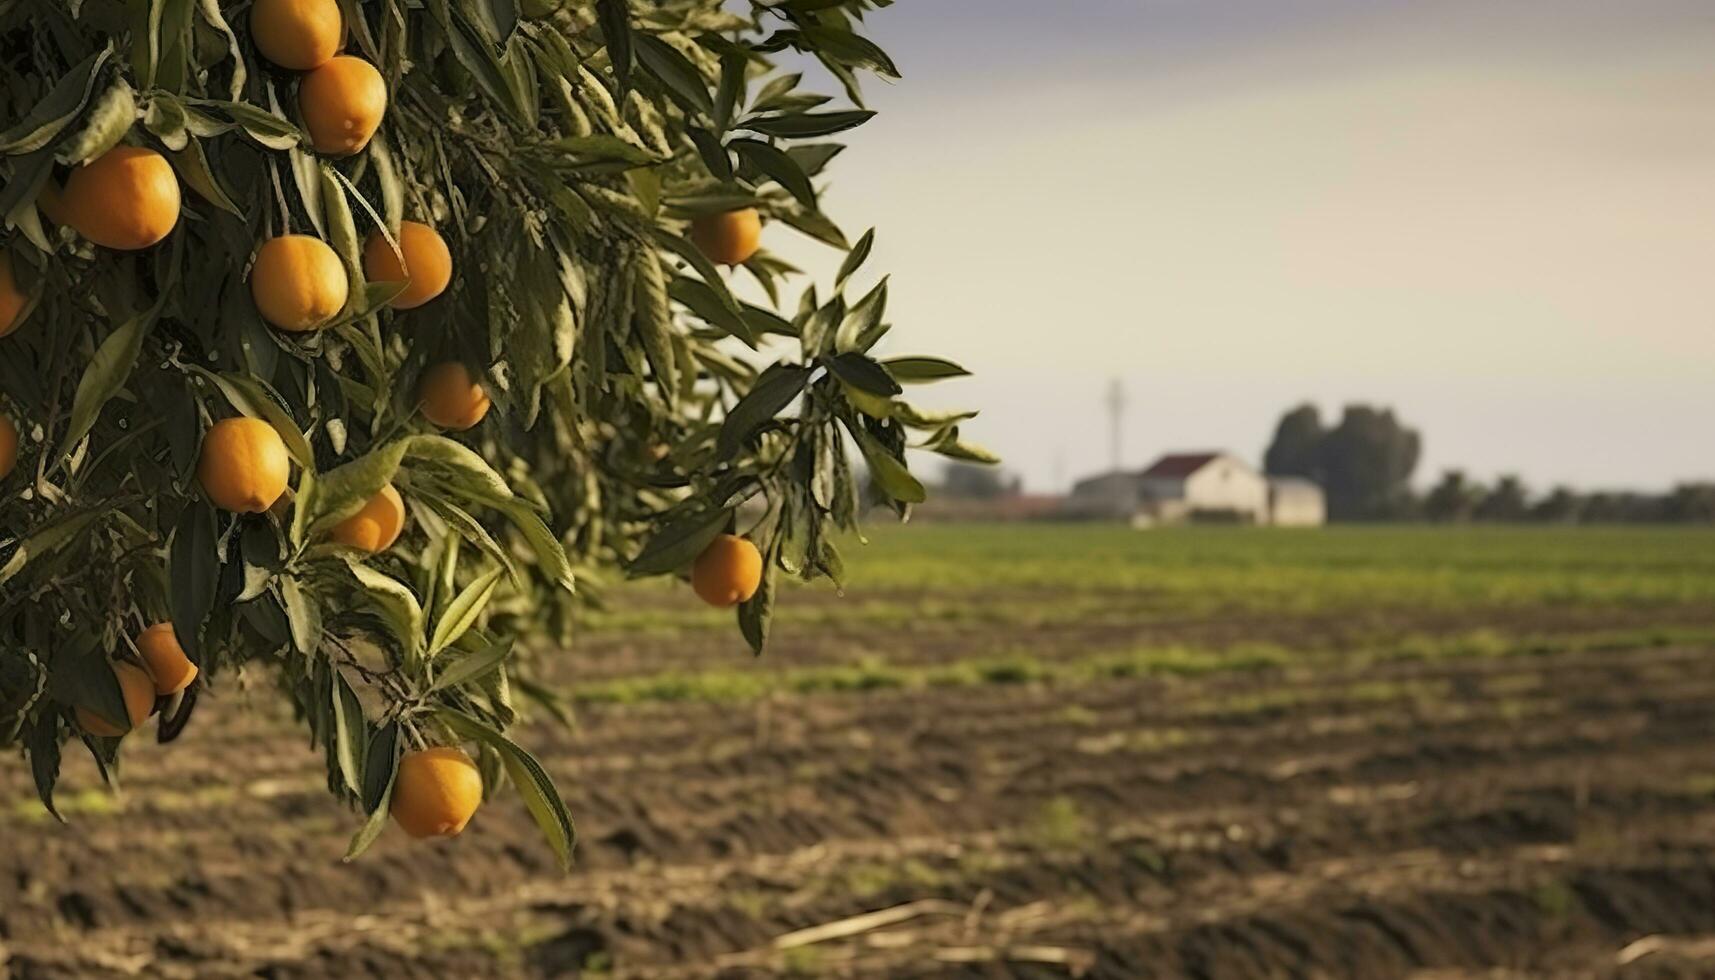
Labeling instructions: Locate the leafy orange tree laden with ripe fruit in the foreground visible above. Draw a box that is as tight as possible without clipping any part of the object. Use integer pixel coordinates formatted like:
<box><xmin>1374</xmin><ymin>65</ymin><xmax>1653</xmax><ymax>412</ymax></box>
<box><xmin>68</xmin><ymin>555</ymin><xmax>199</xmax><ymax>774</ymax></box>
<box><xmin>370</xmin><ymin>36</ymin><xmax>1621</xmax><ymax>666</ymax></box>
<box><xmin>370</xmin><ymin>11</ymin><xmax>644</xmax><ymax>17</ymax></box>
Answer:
<box><xmin>0</xmin><ymin>0</ymin><xmax>984</xmax><ymax>862</ymax></box>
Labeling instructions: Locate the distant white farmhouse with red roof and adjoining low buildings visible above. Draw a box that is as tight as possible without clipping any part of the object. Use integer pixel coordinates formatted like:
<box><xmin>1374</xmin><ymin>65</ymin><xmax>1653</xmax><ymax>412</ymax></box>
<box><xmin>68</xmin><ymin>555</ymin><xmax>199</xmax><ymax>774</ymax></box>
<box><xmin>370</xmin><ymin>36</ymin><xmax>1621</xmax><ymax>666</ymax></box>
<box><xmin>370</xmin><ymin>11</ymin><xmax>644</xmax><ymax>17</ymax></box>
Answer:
<box><xmin>1067</xmin><ymin>451</ymin><xmax>1324</xmax><ymax>527</ymax></box>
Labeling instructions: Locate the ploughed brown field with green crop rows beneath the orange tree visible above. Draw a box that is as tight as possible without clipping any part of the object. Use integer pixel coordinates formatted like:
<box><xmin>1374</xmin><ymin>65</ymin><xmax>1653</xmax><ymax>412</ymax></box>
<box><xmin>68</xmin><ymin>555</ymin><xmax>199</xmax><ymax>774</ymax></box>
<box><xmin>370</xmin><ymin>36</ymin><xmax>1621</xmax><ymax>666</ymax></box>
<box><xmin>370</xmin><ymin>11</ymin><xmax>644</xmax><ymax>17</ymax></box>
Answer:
<box><xmin>0</xmin><ymin>525</ymin><xmax>1715</xmax><ymax>978</ymax></box>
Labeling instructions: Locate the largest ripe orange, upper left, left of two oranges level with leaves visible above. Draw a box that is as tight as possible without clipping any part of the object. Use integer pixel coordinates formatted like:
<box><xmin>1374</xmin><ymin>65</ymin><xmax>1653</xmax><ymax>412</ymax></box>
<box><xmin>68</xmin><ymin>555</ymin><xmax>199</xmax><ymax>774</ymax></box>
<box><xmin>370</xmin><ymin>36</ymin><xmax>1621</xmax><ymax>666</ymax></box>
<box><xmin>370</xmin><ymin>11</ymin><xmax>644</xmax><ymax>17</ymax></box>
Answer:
<box><xmin>53</xmin><ymin>146</ymin><xmax>178</xmax><ymax>249</ymax></box>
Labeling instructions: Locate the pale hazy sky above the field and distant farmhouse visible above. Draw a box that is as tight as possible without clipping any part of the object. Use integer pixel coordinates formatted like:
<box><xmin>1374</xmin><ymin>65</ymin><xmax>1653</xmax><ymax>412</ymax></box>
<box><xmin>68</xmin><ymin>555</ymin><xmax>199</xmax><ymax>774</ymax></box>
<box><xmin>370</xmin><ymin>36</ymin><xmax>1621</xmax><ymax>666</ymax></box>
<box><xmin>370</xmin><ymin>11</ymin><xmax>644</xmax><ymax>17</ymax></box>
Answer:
<box><xmin>765</xmin><ymin>0</ymin><xmax>1715</xmax><ymax>493</ymax></box>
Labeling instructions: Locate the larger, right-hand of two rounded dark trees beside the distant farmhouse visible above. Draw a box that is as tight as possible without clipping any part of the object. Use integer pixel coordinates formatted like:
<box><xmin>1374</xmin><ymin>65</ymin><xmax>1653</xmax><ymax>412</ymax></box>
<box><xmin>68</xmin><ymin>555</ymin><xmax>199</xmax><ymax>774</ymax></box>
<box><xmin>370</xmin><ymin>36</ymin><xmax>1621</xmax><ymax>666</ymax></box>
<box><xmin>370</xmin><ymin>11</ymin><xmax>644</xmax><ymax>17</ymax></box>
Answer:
<box><xmin>1317</xmin><ymin>405</ymin><xmax>1423</xmax><ymax>520</ymax></box>
